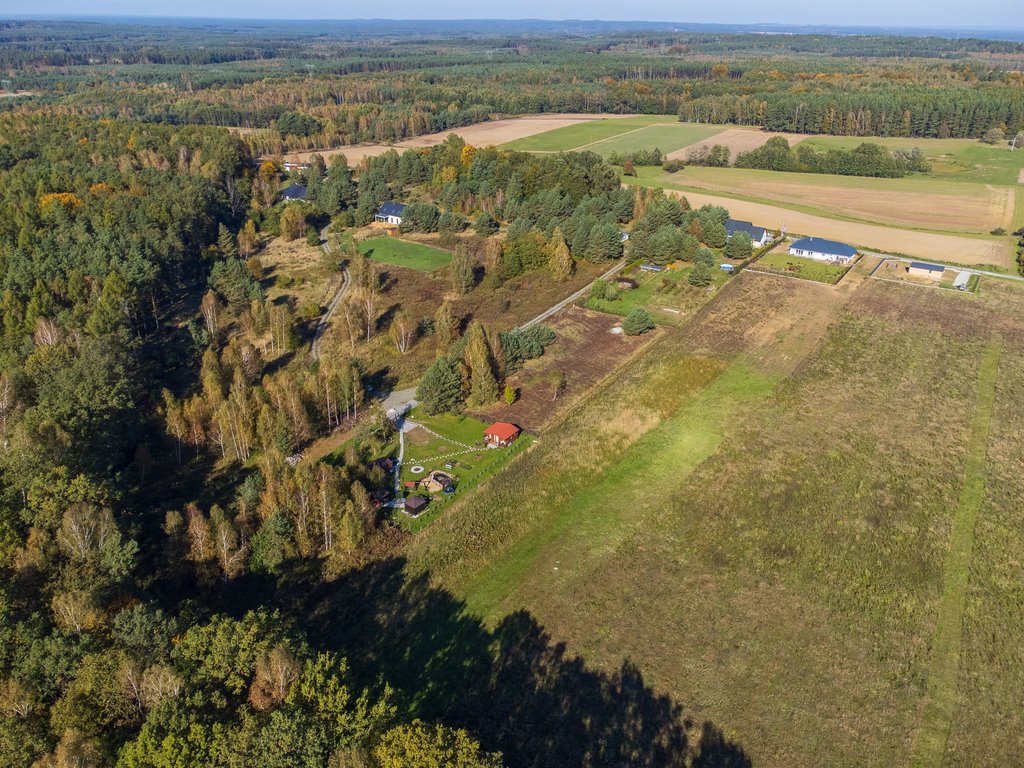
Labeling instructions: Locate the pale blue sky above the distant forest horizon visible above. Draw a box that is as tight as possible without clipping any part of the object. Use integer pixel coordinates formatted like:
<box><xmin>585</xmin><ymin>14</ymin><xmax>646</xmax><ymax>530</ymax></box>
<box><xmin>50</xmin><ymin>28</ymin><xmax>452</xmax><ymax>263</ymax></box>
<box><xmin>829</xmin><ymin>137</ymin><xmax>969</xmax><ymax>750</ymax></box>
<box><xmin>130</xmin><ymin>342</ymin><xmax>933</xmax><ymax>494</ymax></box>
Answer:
<box><xmin>0</xmin><ymin>0</ymin><xmax>1024</xmax><ymax>29</ymax></box>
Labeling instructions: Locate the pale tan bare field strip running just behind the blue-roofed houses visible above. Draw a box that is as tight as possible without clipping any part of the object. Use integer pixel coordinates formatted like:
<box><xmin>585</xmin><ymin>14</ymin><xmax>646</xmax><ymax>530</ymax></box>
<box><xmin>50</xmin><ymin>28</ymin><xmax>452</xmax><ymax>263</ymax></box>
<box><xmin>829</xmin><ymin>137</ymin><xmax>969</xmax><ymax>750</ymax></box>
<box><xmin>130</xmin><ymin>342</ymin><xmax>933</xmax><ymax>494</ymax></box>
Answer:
<box><xmin>674</xmin><ymin>191</ymin><xmax>1013</xmax><ymax>268</ymax></box>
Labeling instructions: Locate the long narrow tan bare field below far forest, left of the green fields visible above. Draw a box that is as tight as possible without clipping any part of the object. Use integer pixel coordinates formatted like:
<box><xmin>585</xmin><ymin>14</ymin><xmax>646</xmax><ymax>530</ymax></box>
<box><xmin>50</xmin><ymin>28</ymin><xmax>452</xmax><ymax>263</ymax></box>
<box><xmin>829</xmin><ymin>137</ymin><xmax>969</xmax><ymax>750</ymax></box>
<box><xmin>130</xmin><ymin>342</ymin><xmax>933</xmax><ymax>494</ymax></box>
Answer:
<box><xmin>272</xmin><ymin>114</ymin><xmax>633</xmax><ymax>165</ymax></box>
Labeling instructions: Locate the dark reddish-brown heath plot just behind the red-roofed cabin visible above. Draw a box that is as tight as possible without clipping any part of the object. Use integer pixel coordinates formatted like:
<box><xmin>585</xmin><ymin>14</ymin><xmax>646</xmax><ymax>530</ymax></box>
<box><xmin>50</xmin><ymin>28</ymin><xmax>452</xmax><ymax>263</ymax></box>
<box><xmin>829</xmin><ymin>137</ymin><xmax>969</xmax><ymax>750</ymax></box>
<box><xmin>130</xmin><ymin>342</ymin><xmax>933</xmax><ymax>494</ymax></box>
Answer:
<box><xmin>475</xmin><ymin>307</ymin><xmax>660</xmax><ymax>432</ymax></box>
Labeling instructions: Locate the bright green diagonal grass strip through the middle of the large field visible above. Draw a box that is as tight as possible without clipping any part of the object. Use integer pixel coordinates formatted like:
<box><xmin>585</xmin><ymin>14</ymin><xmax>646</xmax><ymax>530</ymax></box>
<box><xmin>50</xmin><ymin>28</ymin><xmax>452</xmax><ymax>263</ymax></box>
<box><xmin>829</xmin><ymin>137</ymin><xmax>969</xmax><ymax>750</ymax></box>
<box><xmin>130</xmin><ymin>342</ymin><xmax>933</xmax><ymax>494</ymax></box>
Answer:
<box><xmin>466</xmin><ymin>361</ymin><xmax>778</xmax><ymax>617</ymax></box>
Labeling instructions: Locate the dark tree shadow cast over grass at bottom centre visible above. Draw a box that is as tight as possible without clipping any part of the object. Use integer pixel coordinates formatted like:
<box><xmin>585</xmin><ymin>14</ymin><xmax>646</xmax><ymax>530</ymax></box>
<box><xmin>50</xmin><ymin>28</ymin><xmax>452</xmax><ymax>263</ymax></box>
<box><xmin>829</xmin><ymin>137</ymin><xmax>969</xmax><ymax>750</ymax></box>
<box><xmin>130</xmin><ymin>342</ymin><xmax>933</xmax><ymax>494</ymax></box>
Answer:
<box><xmin>306</xmin><ymin>558</ymin><xmax>751</xmax><ymax>768</ymax></box>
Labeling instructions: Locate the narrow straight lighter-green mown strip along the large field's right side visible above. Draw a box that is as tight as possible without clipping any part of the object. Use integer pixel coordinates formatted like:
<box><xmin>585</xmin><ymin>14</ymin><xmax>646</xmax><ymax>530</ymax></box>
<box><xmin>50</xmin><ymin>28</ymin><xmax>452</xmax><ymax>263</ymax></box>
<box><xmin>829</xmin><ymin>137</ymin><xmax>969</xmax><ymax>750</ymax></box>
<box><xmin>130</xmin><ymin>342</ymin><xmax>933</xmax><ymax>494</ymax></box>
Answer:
<box><xmin>910</xmin><ymin>336</ymin><xmax>1002</xmax><ymax>768</ymax></box>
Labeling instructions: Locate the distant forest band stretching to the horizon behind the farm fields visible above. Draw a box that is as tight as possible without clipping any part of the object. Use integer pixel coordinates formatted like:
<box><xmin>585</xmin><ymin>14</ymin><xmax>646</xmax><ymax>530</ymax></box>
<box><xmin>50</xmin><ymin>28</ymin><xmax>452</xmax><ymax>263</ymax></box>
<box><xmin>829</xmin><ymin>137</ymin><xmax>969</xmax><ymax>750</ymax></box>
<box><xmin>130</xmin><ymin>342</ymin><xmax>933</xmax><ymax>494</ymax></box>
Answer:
<box><xmin>0</xmin><ymin>22</ymin><xmax>1024</xmax><ymax>153</ymax></box>
